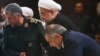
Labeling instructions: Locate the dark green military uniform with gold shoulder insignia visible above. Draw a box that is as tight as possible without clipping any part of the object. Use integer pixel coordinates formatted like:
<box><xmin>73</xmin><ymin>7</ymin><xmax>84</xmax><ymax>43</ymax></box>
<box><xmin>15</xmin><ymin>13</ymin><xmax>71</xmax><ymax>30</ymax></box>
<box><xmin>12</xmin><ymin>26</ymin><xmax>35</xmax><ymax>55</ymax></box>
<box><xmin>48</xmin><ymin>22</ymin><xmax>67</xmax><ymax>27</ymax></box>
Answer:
<box><xmin>3</xmin><ymin>19</ymin><xmax>44</xmax><ymax>56</ymax></box>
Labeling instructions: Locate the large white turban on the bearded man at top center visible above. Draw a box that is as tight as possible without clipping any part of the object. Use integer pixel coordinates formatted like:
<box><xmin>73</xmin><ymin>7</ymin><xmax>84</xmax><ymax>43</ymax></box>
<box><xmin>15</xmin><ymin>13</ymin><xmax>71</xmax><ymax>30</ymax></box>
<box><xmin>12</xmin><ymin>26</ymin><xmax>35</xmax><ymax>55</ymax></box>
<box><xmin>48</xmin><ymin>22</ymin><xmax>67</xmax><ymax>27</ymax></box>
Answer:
<box><xmin>38</xmin><ymin>0</ymin><xmax>62</xmax><ymax>11</ymax></box>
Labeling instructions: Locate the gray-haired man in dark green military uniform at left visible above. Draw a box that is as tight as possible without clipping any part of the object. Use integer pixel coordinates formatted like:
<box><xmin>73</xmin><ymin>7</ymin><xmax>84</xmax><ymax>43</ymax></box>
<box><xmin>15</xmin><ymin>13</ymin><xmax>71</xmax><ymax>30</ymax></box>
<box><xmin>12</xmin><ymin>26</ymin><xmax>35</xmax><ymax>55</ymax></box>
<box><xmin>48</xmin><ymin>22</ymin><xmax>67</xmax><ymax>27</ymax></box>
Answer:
<box><xmin>3</xmin><ymin>3</ymin><xmax>44</xmax><ymax>56</ymax></box>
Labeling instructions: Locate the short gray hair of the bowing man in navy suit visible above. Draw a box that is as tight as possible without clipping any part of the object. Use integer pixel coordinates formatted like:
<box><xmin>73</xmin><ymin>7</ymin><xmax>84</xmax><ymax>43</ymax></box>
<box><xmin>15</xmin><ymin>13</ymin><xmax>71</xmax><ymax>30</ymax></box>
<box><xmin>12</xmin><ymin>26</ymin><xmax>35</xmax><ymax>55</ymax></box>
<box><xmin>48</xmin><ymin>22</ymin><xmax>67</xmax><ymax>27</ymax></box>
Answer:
<box><xmin>45</xmin><ymin>24</ymin><xmax>67</xmax><ymax>34</ymax></box>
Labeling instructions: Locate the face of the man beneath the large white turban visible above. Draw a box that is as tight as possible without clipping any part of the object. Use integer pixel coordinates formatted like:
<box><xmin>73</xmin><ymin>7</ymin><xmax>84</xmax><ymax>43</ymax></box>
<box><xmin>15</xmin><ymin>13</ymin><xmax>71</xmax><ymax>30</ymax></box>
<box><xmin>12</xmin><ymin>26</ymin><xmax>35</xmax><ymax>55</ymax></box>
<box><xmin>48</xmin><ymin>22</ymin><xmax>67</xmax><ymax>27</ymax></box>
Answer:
<box><xmin>39</xmin><ymin>7</ymin><xmax>53</xmax><ymax>22</ymax></box>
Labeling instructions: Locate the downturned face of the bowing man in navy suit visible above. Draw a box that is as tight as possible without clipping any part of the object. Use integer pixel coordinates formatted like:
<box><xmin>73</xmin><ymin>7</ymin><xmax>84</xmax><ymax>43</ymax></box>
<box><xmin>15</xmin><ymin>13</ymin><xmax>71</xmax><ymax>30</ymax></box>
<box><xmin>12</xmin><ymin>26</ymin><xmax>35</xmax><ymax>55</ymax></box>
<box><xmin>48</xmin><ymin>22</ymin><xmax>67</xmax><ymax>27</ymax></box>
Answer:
<box><xmin>45</xmin><ymin>34</ymin><xmax>62</xmax><ymax>49</ymax></box>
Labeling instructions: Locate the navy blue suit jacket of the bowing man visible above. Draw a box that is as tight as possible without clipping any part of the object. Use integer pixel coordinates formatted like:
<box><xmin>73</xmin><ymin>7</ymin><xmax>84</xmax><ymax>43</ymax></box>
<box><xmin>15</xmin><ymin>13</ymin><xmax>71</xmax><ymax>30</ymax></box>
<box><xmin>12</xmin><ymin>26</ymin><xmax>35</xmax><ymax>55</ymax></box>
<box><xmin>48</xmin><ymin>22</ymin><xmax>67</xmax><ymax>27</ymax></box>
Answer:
<box><xmin>63</xmin><ymin>31</ymin><xmax>100</xmax><ymax>56</ymax></box>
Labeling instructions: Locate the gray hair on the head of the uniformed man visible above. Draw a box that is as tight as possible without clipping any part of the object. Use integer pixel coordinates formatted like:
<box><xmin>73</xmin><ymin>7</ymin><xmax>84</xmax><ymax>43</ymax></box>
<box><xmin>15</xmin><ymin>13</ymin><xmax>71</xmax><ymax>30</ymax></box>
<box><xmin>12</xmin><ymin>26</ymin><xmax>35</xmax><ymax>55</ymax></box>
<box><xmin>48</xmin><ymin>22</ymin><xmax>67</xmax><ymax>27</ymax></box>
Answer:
<box><xmin>4</xmin><ymin>3</ymin><xmax>22</xmax><ymax>15</ymax></box>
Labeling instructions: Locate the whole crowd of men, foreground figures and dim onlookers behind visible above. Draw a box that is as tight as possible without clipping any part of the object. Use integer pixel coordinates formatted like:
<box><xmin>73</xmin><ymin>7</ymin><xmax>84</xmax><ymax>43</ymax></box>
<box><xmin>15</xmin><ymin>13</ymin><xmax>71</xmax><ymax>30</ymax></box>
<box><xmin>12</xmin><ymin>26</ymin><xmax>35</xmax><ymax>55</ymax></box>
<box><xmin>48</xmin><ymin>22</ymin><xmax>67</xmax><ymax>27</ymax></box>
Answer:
<box><xmin>0</xmin><ymin>0</ymin><xmax>100</xmax><ymax>56</ymax></box>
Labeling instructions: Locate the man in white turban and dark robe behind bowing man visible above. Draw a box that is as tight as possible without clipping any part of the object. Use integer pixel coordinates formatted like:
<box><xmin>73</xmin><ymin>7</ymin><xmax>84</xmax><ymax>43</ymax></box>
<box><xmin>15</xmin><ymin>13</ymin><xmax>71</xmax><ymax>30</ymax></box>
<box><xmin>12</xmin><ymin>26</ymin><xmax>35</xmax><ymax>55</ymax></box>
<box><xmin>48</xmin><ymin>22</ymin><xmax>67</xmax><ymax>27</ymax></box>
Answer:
<box><xmin>38</xmin><ymin>0</ymin><xmax>77</xmax><ymax>30</ymax></box>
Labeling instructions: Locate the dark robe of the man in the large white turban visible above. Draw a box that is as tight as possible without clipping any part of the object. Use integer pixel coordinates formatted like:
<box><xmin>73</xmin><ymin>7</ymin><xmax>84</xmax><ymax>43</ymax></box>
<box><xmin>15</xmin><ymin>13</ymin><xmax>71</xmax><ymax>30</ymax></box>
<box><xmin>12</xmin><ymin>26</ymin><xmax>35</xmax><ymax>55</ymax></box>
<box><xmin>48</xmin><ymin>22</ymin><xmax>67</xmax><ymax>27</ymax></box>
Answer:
<box><xmin>49</xmin><ymin>13</ymin><xmax>77</xmax><ymax>31</ymax></box>
